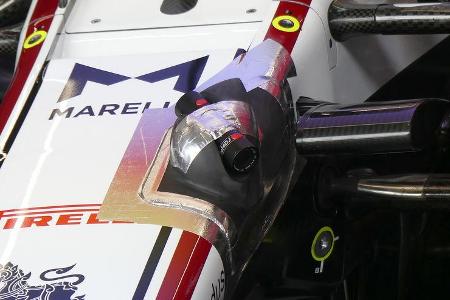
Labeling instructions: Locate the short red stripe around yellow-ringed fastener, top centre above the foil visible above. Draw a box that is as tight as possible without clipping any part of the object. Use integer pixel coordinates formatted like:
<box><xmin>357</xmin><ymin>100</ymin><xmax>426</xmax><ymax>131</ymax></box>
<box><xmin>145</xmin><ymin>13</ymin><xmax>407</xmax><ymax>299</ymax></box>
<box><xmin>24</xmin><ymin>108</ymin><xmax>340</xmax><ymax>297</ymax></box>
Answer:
<box><xmin>264</xmin><ymin>0</ymin><xmax>311</xmax><ymax>53</ymax></box>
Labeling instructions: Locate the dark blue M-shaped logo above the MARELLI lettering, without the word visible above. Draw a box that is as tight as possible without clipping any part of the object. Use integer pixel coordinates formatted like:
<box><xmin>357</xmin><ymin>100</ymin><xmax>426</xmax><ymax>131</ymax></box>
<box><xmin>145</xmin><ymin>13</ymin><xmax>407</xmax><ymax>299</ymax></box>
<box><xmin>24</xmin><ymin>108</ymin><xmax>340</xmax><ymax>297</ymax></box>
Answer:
<box><xmin>58</xmin><ymin>56</ymin><xmax>209</xmax><ymax>102</ymax></box>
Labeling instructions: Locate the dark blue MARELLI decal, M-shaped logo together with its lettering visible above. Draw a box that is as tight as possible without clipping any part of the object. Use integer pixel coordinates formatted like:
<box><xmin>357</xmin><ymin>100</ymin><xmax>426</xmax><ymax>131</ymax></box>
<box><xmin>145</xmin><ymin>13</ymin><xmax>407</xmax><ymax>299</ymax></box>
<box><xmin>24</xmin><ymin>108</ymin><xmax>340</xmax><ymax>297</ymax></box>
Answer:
<box><xmin>48</xmin><ymin>56</ymin><xmax>209</xmax><ymax>120</ymax></box>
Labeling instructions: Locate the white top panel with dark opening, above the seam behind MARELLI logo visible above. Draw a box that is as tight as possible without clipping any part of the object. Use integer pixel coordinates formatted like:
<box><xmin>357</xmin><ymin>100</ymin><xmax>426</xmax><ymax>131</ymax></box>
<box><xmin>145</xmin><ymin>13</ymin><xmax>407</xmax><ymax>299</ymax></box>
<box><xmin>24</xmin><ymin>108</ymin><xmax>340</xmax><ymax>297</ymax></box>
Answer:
<box><xmin>66</xmin><ymin>0</ymin><xmax>267</xmax><ymax>33</ymax></box>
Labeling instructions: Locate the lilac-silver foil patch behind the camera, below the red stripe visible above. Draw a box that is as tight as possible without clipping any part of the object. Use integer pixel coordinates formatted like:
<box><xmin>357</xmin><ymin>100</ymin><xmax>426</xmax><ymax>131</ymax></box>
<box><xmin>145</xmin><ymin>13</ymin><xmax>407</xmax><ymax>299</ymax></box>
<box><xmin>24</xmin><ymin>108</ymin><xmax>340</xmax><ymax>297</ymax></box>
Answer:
<box><xmin>195</xmin><ymin>39</ymin><xmax>294</xmax><ymax>98</ymax></box>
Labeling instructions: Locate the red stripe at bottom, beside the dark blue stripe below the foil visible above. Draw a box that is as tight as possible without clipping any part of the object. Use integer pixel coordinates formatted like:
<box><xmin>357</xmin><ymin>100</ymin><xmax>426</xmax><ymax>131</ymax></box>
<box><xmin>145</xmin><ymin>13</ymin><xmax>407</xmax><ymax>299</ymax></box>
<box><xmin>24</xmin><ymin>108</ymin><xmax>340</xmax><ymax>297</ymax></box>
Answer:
<box><xmin>156</xmin><ymin>231</ymin><xmax>211</xmax><ymax>300</ymax></box>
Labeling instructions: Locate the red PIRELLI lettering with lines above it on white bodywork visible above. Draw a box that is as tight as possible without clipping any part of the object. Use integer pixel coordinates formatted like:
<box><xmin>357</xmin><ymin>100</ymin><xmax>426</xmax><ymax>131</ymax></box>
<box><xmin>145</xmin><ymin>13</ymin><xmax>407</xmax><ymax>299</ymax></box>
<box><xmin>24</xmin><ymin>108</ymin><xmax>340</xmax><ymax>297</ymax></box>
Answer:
<box><xmin>0</xmin><ymin>204</ymin><xmax>129</xmax><ymax>230</ymax></box>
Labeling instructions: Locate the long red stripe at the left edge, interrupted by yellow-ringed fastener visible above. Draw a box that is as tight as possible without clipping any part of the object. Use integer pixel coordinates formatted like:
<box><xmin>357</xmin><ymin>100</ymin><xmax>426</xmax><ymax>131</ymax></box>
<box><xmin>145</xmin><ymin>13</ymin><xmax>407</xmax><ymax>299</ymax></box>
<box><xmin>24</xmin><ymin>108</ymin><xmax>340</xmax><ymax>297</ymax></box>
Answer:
<box><xmin>0</xmin><ymin>0</ymin><xmax>58</xmax><ymax>133</ymax></box>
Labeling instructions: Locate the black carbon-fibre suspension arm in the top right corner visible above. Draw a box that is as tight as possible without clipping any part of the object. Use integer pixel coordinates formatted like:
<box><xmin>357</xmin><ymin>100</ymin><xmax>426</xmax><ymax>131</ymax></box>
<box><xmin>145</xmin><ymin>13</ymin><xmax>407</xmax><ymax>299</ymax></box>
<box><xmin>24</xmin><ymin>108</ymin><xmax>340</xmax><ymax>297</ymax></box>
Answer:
<box><xmin>328</xmin><ymin>0</ymin><xmax>450</xmax><ymax>41</ymax></box>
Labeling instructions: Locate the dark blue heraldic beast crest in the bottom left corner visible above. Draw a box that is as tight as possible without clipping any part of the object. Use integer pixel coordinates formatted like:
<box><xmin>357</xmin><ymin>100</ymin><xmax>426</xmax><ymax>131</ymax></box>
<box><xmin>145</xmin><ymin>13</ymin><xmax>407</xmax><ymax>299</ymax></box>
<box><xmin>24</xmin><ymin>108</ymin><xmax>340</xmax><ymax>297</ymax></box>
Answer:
<box><xmin>0</xmin><ymin>263</ymin><xmax>85</xmax><ymax>300</ymax></box>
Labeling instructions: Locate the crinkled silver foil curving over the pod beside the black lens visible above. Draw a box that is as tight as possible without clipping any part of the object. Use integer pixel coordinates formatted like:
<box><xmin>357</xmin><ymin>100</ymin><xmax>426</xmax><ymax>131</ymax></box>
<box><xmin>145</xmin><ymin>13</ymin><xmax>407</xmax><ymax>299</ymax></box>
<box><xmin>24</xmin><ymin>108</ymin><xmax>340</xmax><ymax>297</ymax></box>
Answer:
<box><xmin>170</xmin><ymin>101</ymin><xmax>257</xmax><ymax>173</ymax></box>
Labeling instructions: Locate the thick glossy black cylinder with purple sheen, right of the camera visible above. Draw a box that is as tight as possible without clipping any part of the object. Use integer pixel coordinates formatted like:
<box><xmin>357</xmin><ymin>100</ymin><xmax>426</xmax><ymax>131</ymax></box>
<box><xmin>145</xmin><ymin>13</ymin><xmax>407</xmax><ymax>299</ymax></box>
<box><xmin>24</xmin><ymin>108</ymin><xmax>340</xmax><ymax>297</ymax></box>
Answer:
<box><xmin>296</xmin><ymin>99</ymin><xmax>448</xmax><ymax>154</ymax></box>
